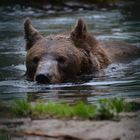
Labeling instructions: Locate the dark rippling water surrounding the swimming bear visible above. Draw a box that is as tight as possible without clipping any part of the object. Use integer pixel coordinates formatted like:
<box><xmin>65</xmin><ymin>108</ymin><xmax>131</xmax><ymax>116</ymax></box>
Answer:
<box><xmin>0</xmin><ymin>5</ymin><xmax>140</xmax><ymax>103</ymax></box>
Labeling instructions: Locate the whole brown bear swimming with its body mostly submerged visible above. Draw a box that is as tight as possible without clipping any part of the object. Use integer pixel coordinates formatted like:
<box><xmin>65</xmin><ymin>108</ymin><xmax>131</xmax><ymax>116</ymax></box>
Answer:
<box><xmin>24</xmin><ymin>18</ymin><xmax>140</xmax><ymax>83</ymax></box>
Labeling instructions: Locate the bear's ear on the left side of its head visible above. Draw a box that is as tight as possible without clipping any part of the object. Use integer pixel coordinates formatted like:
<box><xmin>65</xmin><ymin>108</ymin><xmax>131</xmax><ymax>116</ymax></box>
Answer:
<box><xmin>24</xmin><ymin>18</ymin><xmax>43</xmax><ymax>51</ymax></box>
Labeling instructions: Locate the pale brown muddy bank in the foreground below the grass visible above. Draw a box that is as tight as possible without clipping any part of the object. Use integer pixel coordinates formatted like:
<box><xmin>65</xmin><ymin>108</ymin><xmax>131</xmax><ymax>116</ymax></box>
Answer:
<box><xmin>0</xmin><ymin>99</ymin><xmax>140</xmax><ymax>140</ymax></box>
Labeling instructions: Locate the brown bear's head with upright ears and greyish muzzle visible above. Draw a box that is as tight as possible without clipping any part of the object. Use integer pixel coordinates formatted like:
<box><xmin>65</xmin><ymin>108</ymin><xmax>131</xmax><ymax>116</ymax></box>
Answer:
<box><xmin>24</xmin><ymin>18</ymin><xmax>98</xmax><ymax>83</ymax></box>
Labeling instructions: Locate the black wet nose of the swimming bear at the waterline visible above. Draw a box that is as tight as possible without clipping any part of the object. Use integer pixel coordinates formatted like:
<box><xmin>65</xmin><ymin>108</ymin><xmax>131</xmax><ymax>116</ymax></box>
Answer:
<box><xmin>35</xmin><ymin>74</ymin><xmax>50</xmax><ymax>83</ymax></box>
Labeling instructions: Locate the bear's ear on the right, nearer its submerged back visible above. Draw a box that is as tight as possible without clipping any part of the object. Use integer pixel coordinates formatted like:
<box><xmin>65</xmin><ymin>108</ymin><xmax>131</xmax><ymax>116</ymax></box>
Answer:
<box><xmin>71</xmin><ymin>18</ymin><xmax>87</xmax><ymax>39</ymax></box>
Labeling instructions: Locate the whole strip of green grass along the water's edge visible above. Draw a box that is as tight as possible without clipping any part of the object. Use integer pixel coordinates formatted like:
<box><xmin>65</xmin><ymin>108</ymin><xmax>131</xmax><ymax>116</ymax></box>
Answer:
<box><xmin>10</xmin><ymin>98</ymin><xmax>131</xmax><ymax>120</ymax></box>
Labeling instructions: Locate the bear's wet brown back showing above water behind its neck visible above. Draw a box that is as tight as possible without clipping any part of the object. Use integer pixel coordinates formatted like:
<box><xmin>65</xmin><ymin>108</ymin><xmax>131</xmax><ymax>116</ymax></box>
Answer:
<box><xmin>99</xmin><ymin>41</ymin><xmax>140</xmax><ymax>63</ymax></box>
